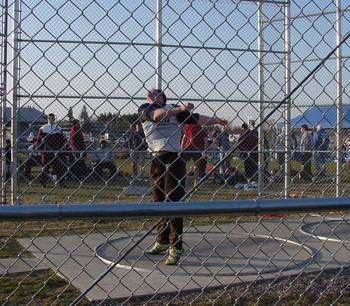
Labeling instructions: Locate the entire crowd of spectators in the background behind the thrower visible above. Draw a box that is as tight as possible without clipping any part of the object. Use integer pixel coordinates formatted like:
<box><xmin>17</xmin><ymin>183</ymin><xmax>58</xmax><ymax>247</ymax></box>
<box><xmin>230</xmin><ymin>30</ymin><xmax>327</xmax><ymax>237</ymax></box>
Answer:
<box><xmin>6</xmin><ymin>104</ymin><xmax>331</xmax><ymax>187</ymax></box>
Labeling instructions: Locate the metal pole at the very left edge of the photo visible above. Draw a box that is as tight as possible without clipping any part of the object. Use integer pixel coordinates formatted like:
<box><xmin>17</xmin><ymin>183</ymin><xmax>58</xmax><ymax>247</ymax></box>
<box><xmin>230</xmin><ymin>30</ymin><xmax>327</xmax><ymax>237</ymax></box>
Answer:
<box><xmin>0</xmin><ymin>0</ymin><xmax>9</xmax><ymax>204</ymax></box>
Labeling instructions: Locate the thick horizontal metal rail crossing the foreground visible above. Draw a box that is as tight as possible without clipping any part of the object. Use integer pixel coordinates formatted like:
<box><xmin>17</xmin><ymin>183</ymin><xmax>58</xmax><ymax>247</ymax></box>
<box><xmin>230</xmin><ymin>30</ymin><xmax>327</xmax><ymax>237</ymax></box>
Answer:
<box><xmin>0</xmin><ymin>197</ymin><xmax>350</xmax><ymax>221</ymax></box>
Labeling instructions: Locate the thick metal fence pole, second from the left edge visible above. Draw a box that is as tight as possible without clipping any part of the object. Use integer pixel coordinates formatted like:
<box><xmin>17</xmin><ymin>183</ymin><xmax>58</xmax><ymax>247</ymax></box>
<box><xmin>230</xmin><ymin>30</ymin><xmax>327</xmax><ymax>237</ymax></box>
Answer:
<box><xmin>11</xmin><ymin>0</ymin><xmax>19</xmax><ymax>205</ymax></box>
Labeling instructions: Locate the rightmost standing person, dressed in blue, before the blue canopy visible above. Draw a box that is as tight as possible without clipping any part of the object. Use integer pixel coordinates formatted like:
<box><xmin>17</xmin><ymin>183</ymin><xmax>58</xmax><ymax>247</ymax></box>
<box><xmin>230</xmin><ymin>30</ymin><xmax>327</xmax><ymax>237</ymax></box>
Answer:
<box><xmin>314</xmin><ymin>125</ymin><xmax>329</xmax><ymax>176</ymax></box>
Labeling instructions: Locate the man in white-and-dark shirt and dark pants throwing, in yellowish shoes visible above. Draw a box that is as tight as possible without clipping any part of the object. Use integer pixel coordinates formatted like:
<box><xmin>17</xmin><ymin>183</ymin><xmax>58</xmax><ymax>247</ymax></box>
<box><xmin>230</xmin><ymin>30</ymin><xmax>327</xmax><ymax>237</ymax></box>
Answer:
<box><xmin>139</xmin><ymin>89</ymin><xmax>227</xmax><ymax>265</ymax></box>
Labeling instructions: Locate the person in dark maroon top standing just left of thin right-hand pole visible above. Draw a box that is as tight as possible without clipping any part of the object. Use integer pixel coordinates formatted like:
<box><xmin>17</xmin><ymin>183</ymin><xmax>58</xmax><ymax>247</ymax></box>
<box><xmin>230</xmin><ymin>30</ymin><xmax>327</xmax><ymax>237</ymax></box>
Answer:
<box><xmin>238</xmin><ymin>123</ymin><xmax>258</xmax><ymax>182</ymax></box>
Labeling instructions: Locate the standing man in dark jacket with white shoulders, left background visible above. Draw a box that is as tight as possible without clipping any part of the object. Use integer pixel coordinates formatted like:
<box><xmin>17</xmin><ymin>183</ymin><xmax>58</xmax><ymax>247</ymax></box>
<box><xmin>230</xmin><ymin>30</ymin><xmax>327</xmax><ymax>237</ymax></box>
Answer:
<box><xmin>36</xmin><ymin>113</ymin><xmax>66</xmax><ymax>187</ymax></box>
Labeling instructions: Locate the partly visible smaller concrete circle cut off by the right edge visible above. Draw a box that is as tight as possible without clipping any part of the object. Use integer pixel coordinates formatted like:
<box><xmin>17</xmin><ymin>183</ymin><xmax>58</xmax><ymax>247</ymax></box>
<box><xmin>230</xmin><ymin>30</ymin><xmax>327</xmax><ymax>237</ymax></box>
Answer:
<box><xmin>301</xmin><ymin>219</ymin><xmax>350</xmax><ymax>243</ymax></box>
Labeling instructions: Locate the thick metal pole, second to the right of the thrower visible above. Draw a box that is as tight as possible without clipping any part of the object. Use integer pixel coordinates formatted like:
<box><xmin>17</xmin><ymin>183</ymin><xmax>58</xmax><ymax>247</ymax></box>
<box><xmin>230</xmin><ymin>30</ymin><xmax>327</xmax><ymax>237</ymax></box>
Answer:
<box><xmin>284</xmin><ymin>1</ymin><xmax>291</xmax><ymax>198</ymax></box>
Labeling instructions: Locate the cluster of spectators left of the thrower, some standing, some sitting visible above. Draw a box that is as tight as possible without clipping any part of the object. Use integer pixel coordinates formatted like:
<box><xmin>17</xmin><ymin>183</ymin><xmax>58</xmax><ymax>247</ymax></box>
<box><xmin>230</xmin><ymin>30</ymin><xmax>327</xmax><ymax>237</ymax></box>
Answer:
<box><xmin>17</xmin><ymin>113</ymin><xmax>117</xmax><ymax>187</ymax></box>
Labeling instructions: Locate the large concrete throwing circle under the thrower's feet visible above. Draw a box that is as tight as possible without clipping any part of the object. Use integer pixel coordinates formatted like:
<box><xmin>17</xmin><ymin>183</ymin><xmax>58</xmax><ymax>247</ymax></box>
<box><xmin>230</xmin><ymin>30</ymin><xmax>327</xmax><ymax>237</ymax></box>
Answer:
<box><xmin>96</xmin><ymin>232</ymin><xmax>313</xmax><ymax>276</ymax></box>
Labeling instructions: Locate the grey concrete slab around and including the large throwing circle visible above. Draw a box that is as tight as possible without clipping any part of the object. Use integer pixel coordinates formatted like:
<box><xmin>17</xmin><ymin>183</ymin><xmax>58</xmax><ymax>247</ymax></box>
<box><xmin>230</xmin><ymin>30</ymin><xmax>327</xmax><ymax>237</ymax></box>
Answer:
<box><xmin>15</xmin><ymin>218</ymin><xmax>350</xmax><ymax>300</ymax></box>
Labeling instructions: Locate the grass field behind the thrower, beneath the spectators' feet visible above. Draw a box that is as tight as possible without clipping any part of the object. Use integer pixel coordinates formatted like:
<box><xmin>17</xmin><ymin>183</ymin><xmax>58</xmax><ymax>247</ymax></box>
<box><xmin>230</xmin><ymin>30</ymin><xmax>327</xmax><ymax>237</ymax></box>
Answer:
<box><xmin>7</xmin><ymin>159</ymin><xmax>350</xmax><ymax>204</ymax></box>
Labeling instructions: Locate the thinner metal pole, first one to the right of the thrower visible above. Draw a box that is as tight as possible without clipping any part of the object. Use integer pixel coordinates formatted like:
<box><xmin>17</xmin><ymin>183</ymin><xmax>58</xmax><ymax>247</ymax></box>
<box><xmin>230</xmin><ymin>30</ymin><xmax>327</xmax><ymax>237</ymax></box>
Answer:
<box><xmin>258</xmin><ymin>2</ymin><xmax>264</xmax><ymax>195</ymax></box>
